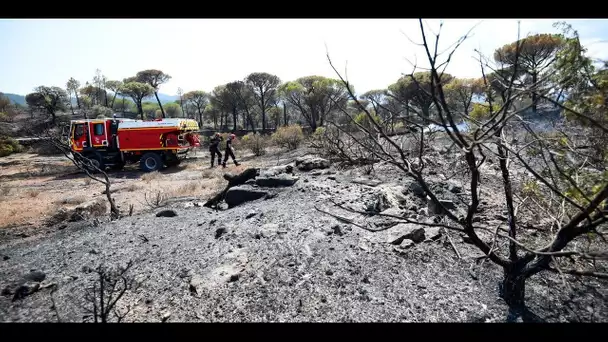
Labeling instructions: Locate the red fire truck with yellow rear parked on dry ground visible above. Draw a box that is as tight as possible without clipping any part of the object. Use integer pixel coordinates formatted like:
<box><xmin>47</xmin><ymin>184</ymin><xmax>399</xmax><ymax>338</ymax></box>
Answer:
<box><xmin>69</xmin><ymin>118</ymin><xmax>200</xmax><ymax>172</ymax></box>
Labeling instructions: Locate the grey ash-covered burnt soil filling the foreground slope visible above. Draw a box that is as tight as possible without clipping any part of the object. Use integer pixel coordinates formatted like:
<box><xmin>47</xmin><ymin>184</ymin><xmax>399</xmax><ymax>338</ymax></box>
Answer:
<box><xmin>0</xmin><ymin>148</ymin><xmax>608</xmax><ymax>322</ymax></box>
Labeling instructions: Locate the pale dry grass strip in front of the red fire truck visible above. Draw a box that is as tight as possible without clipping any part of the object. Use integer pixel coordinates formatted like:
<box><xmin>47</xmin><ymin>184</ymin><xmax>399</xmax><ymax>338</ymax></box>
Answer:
<box><xmin>0</xmin><ymin>151</ymin><xmax>274</xmax><ymax>229</ymax></box>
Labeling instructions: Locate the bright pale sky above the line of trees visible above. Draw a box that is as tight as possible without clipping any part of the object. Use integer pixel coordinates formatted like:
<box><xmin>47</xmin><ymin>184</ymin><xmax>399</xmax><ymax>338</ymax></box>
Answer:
<box><xmin>0</xmin><ymin>19</ymin><xmax>608</xmax><ymax>95</ymax></box>
